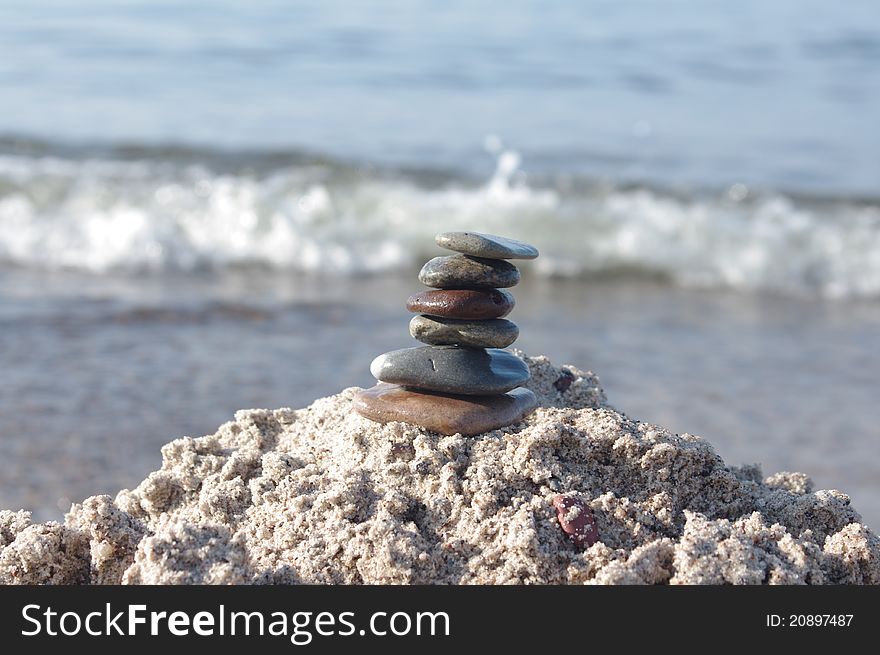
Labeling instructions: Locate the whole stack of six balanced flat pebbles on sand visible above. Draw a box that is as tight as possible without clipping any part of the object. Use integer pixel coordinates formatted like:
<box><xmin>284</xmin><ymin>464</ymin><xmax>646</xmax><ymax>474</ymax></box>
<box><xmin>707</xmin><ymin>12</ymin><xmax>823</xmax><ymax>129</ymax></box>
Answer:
<box><xmin>354</xmin><ymin>232</ymin><xmax>538</xmax><ymax>435</ymax></box>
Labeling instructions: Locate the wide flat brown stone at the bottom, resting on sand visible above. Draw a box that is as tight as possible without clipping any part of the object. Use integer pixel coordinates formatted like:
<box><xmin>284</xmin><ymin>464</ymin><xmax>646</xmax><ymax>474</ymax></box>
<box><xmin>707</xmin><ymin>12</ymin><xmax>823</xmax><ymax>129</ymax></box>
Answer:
<box><xmin>354</xmin><ymin>382</ymin><xmax>538</xmax><ymax>436</ymax></box>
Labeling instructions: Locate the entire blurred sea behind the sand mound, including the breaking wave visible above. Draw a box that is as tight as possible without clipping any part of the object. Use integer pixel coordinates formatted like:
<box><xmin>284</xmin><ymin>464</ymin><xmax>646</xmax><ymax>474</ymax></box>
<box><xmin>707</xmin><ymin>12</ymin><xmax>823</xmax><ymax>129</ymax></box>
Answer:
<box><xmin>0</xmin><ymin>0</ymin><xmax>880</xmax><ymax>526</ymax></box>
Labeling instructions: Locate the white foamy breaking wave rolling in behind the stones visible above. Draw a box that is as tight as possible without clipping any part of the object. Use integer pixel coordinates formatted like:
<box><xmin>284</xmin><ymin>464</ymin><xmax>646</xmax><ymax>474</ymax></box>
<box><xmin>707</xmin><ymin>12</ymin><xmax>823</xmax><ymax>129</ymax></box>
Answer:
<box><xmin>0</xmin><ymin>146</ymin><xmax>880</xmax><ymax>297</ymax></box>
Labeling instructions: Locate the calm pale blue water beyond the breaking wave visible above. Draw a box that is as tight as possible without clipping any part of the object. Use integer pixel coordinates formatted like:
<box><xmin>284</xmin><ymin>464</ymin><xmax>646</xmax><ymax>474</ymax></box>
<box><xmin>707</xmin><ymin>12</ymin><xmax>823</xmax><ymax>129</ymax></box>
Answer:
<box><xmin>0</xmin><ymin>0</ymin><xmax>880</xmax><ymax>197</ymax></box>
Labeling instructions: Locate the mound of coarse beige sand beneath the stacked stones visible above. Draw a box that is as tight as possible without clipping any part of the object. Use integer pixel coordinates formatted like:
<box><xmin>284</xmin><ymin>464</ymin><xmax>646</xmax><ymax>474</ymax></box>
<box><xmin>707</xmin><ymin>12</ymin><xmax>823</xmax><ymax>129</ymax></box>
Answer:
<box><xmin>0</xmin><ymin>357</ymin><xmax>880</xmax><ymax>584</ymax></box>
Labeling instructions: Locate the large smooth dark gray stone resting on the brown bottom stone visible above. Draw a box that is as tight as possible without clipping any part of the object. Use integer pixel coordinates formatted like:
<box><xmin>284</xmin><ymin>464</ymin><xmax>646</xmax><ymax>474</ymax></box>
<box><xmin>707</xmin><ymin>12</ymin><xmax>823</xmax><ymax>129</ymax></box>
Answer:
<box><xmin>370</xmin><ymin>346</ymin><xmax>529</xmax><ymax>396</ymax></box>
